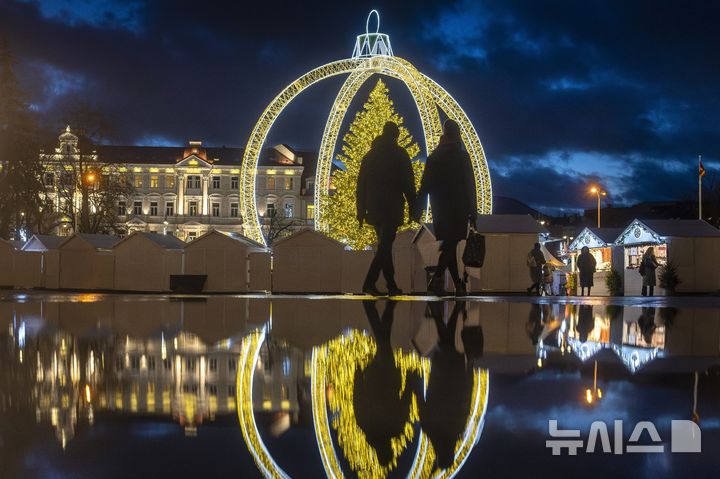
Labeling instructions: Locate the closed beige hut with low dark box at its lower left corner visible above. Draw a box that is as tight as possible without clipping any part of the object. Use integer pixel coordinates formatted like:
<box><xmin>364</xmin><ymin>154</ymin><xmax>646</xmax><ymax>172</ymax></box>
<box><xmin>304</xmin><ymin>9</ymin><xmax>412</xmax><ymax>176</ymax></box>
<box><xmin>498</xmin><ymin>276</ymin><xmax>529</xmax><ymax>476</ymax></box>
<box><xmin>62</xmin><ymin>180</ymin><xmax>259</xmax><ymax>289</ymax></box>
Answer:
<box><xmin>184</xmin><ymin>230</ymin><xmax>270</xmax><ymax>293</ymax></box>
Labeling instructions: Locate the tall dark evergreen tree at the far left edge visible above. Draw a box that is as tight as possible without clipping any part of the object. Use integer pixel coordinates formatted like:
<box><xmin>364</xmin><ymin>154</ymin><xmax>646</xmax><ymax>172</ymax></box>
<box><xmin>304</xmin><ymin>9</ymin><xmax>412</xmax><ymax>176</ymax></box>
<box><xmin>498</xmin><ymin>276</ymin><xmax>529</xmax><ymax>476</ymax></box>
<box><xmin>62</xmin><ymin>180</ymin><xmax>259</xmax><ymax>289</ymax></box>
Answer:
<box><xmin>0</xmin><ymin>38</ymin><xmax>42</xmax><ymax>238</ymax></box>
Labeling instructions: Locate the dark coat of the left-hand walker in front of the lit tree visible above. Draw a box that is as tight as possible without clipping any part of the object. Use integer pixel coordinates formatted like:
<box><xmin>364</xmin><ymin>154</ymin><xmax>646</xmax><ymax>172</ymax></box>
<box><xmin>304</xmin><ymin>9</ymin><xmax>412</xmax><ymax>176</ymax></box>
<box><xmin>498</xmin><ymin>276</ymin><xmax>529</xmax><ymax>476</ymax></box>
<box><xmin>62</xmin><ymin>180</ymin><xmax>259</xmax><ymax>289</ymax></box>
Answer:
<box><xmin>357</xmin><ymin>135</ymin><xmax>415</xmax><ymax>227</ymax></box>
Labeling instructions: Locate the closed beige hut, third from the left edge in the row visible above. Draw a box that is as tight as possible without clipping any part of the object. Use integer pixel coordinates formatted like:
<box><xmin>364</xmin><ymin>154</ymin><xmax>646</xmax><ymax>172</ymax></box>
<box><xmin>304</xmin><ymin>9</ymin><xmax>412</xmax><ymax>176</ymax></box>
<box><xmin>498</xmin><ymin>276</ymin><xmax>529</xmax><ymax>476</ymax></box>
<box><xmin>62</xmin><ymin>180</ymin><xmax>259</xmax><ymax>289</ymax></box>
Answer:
<box><xmin>58</xmin><ymin>233</ymin><xmax>122</xmax><ymax>290</ymax></box>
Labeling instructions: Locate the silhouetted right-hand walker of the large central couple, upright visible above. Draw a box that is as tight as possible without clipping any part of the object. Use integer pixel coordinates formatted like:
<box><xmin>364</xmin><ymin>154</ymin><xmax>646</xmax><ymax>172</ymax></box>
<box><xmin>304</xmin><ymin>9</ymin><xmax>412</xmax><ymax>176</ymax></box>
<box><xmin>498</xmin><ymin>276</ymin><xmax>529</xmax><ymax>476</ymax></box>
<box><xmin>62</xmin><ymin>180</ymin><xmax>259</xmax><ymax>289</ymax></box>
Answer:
<box><xmin>414</xmin><ymin>120</ymin><xmax>477</xmax><ymax>296</ymax></box>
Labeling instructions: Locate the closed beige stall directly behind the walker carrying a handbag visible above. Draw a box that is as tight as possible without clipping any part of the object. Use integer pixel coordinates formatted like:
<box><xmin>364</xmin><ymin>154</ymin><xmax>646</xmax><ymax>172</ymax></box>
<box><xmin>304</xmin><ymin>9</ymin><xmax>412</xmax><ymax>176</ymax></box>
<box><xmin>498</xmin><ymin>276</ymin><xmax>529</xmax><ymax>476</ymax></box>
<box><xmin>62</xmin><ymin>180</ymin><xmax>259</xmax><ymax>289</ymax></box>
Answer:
<box><xmin>414</xmin><ymin>215</ymin><xmax>548</xmax><ymax>292</ymax></box>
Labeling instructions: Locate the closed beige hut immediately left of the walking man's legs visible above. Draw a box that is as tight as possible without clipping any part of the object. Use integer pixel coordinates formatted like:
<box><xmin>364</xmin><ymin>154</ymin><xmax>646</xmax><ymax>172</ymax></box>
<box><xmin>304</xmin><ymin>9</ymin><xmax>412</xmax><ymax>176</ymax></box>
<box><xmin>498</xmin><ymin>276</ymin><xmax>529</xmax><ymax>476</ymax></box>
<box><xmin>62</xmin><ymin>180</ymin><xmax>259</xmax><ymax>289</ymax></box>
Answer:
<box><xmin>272</xmin><ymin>228</ymin><xmax>345</xmax><ymax>293</ymax></box>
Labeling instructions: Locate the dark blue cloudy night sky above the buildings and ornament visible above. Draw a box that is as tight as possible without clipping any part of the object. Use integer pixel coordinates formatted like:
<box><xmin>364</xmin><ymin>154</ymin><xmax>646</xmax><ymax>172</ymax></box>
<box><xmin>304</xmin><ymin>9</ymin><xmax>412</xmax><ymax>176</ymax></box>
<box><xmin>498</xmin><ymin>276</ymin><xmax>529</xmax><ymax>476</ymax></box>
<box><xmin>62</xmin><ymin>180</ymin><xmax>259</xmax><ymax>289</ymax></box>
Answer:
<box><xmin>0</xmin><ymin>0</ymin><xmax>720</xmax><ymax>211</ymax></box>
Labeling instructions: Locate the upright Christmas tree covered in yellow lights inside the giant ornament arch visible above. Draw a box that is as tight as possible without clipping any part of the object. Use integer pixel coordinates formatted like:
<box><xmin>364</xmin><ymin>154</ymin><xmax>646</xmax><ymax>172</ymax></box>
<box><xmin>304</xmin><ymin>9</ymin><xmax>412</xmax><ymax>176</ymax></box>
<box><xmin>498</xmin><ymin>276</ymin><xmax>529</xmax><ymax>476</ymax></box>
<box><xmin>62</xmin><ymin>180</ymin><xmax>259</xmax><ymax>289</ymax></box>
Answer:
<box><xmin>325</xmin><ymin>80</ymin><xmax>424</xmax><ymax>250</ymax></box>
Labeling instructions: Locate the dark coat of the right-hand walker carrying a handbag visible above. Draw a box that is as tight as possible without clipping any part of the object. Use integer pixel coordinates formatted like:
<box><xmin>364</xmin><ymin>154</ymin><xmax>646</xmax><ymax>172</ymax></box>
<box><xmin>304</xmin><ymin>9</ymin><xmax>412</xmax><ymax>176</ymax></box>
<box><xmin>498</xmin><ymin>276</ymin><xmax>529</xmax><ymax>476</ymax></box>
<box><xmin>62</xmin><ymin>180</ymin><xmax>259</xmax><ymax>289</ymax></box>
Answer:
<box><xmin>416</xmin><ymin>141</ymin><xmax>477</xmax><ymax>241</ymax></box>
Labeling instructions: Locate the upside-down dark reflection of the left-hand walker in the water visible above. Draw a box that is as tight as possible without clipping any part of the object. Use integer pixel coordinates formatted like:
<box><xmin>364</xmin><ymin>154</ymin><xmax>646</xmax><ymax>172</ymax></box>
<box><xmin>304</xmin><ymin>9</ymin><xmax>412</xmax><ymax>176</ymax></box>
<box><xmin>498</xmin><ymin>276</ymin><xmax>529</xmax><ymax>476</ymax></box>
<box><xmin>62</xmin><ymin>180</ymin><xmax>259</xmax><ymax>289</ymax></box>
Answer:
<box><xmin>353</xmin><ymin>301</ymin><xmax>412</xmax><ymax>465</ymax></box>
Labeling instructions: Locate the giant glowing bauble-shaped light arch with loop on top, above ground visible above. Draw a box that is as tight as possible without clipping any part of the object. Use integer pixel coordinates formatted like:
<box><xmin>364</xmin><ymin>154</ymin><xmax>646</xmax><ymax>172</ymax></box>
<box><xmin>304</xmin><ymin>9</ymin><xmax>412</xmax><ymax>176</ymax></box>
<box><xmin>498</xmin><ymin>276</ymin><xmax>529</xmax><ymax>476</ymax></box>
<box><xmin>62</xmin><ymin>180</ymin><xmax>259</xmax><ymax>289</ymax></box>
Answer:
<box><xmin>240</xmin><ymin>10</ymin><xmax>492</xmax><ymax>244</ymax></box>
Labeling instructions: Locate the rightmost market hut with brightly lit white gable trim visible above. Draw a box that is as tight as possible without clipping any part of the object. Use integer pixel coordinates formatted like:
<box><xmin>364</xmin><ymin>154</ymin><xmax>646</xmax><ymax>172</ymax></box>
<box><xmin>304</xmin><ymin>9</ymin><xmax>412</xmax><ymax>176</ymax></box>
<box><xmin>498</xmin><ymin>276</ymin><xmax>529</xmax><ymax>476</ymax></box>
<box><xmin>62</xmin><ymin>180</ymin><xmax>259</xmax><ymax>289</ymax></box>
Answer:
<box><xmin>615</xmin><ymin>219</ymin><xmax>720</xmax><ymax>296</ymax></box>
